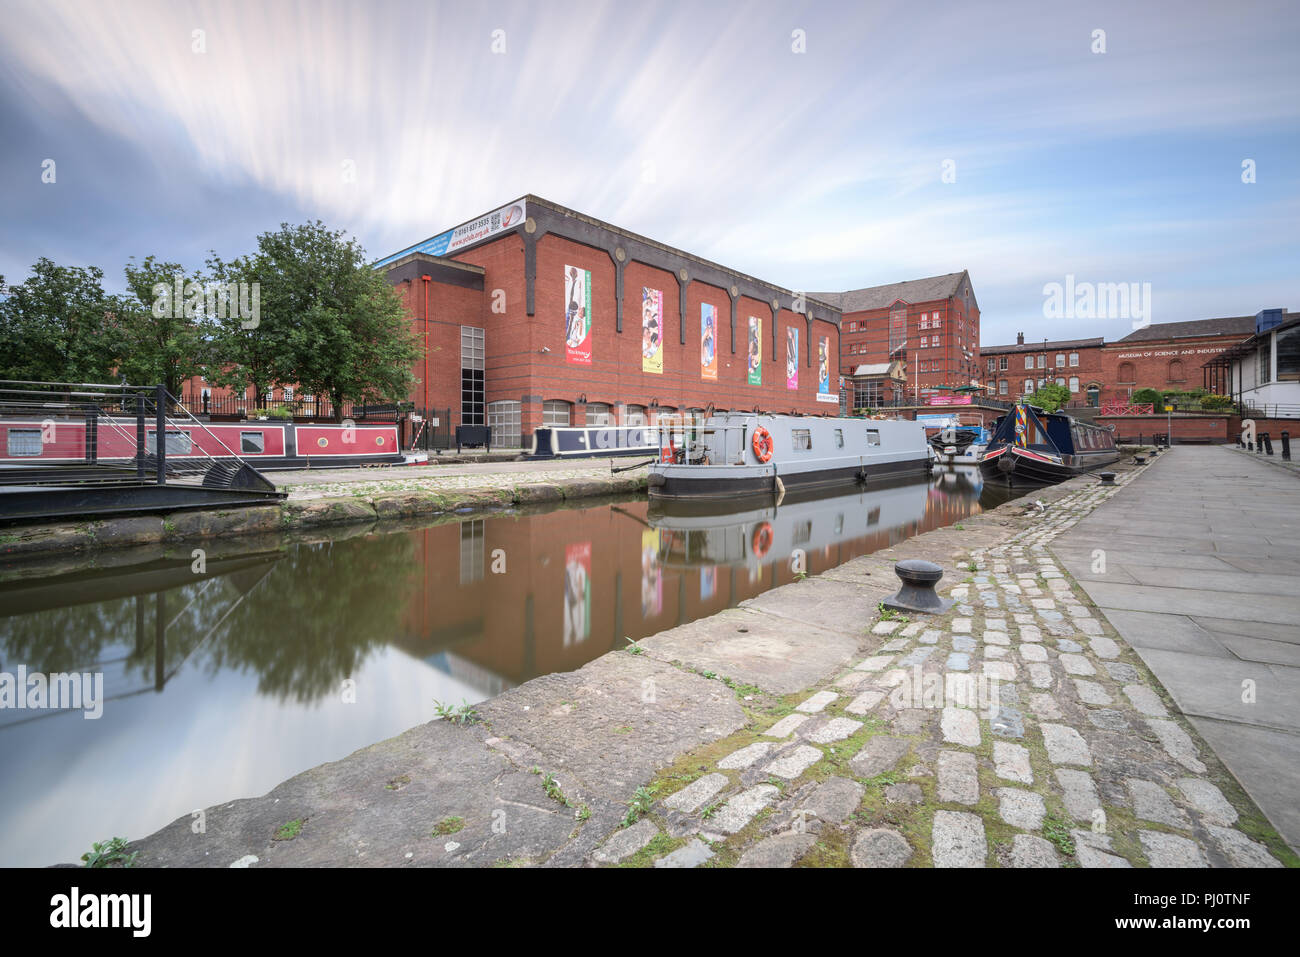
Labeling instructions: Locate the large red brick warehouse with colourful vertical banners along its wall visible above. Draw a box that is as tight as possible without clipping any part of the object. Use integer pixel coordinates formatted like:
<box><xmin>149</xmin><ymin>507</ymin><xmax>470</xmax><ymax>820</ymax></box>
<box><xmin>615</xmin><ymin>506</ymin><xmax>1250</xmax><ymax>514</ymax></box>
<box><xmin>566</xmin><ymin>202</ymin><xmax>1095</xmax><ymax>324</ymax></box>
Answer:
<box><xmin>376</xmin><ymin>195</ymin><xmax>841</xmax><ymax>446</ymax></box>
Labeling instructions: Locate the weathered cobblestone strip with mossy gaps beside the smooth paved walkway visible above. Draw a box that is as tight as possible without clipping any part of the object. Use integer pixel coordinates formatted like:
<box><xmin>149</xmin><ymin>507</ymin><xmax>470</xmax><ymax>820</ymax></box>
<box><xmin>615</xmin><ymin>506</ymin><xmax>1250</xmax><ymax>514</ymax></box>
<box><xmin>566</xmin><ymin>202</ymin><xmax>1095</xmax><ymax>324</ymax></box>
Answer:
<box><xmin>589</xmin><ymin>473</ymin><xmax>1281</xmax><ymax>867</ymax></box>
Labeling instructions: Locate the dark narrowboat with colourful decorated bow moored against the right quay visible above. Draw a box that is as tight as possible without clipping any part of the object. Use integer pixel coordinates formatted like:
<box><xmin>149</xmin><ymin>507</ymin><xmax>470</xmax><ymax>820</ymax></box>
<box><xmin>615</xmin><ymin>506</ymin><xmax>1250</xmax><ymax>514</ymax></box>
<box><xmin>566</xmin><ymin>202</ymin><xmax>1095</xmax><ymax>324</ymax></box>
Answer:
<box><xmin>979</xmin><ymin>404</ymin><xmax>1119</xmax><ymax>485</ymax></box>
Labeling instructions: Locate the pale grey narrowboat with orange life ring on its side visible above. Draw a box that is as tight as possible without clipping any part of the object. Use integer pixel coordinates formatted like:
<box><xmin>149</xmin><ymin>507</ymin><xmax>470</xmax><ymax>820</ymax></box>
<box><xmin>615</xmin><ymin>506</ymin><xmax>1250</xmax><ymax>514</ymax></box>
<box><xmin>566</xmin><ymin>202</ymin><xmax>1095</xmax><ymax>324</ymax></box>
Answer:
<box><xmin>646</xmin><ymin>412</ymin><xmax>932</xmax><ymax>501</ymax></box>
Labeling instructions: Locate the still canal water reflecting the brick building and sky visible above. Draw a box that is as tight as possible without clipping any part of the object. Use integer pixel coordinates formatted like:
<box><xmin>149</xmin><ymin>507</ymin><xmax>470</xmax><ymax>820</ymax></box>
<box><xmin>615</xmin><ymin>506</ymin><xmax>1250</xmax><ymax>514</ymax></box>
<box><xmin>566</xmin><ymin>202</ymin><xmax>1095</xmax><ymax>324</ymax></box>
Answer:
<box><xmin>0</xmin><ymin>468</ymin><xmax>1019</xmax><ymax>866</ymax></box>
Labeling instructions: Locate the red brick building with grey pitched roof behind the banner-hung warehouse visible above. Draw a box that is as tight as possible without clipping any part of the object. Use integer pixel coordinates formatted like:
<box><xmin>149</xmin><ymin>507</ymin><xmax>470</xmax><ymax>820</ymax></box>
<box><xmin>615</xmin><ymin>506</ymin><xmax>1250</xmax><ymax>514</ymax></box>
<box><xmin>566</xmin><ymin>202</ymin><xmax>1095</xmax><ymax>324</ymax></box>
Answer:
<box><xmin>810</xmin><ymin>269</ymin><xmax>980</xmax><ymax>407</ymax></box>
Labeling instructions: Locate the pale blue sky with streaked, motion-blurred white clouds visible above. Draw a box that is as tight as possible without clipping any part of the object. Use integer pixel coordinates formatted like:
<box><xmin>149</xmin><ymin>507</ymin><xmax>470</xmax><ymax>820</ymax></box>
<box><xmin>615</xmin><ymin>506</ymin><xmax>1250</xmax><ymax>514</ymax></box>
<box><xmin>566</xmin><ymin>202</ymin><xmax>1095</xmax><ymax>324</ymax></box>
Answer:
<box><xmin>0</xmin><ymin>0</ymin><xmax>1300</xmax><ymax>346</ymax></box>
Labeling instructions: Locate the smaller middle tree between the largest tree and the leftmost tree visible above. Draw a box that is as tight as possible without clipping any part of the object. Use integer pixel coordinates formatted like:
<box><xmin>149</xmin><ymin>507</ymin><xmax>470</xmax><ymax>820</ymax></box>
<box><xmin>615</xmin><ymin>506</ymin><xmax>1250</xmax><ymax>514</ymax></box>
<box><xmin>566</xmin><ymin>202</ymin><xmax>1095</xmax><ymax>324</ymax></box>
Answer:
<box><xmin>120</xmin><ymin>256</ymin><xmax>209</xmax><ymax>398</ymax></box>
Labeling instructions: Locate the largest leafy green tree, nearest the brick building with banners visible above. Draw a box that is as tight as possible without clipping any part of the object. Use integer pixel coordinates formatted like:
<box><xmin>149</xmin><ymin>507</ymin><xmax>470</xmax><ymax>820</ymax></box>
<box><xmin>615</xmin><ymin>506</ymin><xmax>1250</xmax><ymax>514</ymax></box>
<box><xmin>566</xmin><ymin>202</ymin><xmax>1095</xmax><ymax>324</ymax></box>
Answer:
<box><xmin>256</xmin><ymin>221</ymin><xmax>421</xmax><ymax>421</ymax></box>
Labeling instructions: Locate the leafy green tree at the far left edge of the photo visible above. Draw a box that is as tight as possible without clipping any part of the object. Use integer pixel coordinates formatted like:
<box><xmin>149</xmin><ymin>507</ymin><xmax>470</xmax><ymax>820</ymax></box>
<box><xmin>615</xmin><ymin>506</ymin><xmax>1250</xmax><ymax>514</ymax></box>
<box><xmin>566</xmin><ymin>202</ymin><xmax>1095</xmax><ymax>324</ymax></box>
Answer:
<box><xmin>0</xmin><ymin>256</ymin><xmax>118</xmax><ymax>382</ymax></box>
